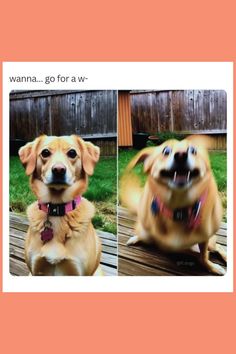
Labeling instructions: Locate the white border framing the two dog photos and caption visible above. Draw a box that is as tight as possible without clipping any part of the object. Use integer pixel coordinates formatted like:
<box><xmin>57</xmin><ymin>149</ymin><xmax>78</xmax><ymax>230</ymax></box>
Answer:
<box><xmin>3</xmin><ymin>62</ymin><xmax>233</xmax><ymax>292</ymax></box>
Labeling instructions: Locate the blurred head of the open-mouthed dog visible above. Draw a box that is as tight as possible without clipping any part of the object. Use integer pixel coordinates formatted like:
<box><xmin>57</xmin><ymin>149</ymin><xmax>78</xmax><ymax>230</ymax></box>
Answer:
<box><xmin>128</xmin><ymin>136</ymin><xmax>211</xmax><ymax>191</ymax></box>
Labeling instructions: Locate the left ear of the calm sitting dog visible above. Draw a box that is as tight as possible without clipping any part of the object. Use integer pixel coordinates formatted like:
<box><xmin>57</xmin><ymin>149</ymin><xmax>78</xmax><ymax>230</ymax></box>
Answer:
<box><xmin>18</xmin><ymin>137</ymin><xmax>41</xmax><ymax>176</ymax></box>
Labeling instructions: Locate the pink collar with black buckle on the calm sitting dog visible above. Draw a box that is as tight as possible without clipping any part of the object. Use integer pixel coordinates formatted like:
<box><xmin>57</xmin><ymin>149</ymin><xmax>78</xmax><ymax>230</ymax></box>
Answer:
<box><xmin>38</xmin><ymin>195</ymin><xmax>81</xmax><ymax>216</ymax></box>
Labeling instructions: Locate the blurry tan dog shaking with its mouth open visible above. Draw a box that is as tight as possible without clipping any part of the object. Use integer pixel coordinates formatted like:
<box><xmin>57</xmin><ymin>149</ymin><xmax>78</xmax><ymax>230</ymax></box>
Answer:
<box><xmin>120</xmin><ymin>136</ymin><xmax>226</xmax><ymax>275</ymax></box>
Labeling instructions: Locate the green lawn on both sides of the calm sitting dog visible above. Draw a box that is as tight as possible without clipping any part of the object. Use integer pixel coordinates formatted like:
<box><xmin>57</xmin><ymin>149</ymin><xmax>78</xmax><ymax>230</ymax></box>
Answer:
<box><xmin>10</xmin><ymin>156</ymin><xmax>117</xmax><ymax>234</ymax></box>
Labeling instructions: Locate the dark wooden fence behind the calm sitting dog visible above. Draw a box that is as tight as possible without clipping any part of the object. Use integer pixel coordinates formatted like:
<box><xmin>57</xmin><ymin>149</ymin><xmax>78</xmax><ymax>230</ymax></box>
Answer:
<box><xmin>10</xmin><ymin>90</ymin><xmax>117</xmax><ymax>155</ymax></box>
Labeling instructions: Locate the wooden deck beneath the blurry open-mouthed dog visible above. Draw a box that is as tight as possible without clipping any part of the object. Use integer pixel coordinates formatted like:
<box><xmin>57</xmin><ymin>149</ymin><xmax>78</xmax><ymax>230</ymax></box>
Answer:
<box><xmin>118</xmin><ymin>207</ymin><xmax>227</xmax><ymax>275</ymax></box>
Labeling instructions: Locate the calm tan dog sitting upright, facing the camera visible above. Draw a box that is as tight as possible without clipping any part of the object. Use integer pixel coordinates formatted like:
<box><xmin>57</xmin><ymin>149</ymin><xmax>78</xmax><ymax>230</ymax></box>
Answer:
<box><xmin>19</xmin><ymin>135</ymin><xmax>101</xmax><ymax>275</ymax></box>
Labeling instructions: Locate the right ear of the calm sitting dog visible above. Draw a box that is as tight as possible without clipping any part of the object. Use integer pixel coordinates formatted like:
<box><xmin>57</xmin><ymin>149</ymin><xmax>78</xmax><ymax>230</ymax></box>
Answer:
<box><xmin>75</xmin><ymin>136</ymin><xmax>100</xmax><ymax>176</ymax></box>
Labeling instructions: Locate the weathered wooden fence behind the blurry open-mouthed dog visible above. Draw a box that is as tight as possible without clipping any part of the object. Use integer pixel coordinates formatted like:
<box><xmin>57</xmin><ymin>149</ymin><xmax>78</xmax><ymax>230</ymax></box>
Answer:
<box><xmin>131</xmin><ymin>90</ymin><xmax>227</xmax><ymax>149</ymax></box>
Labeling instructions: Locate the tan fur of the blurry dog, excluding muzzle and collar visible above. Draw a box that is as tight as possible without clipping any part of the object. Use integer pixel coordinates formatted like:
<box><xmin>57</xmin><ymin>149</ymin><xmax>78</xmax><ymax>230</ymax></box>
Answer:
<box><xmin>120</xmin><ymin>136</ymin><xmax>226</xmax><ymax>275</ymax></box>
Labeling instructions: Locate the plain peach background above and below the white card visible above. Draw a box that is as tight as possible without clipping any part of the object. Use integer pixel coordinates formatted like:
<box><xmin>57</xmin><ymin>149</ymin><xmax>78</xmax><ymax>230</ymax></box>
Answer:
<box><xmin>0</xmin><ymin>0</ymin><xmax>236</xmax><ymax>354</ymax></box>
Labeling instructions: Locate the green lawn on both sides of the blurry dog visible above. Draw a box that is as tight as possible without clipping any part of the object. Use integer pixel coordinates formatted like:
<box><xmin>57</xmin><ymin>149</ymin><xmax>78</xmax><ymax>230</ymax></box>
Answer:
<box><xmin>119</xmin><ymin>149</ymin><xmax>227</xmax><ymax>221</ymax></box>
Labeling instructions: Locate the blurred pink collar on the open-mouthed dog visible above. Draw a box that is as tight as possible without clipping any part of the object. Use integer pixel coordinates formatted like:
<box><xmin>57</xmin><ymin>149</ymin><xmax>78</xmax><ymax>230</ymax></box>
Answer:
<box><xmin>151</xmin><ymin>190</ymin><xmax>208</xmax><ymax>230</ymax></box>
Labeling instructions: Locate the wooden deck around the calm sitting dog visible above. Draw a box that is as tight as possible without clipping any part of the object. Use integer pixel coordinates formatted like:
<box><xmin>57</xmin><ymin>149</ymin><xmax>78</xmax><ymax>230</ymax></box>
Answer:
<box><xmin>10</xmin><ymin>213</ymin><xmax>117</xmax><ymax>276</ymax></box>
